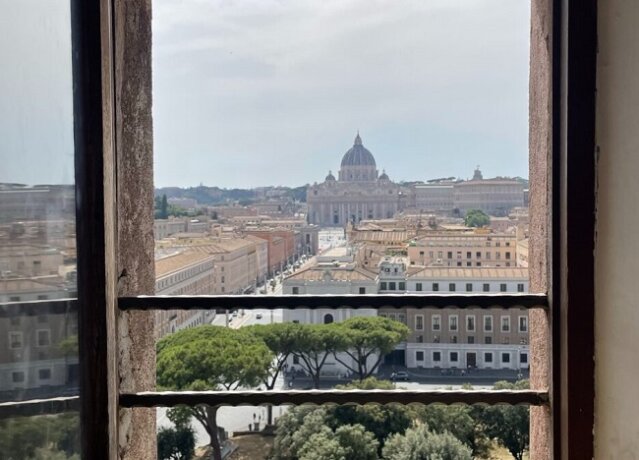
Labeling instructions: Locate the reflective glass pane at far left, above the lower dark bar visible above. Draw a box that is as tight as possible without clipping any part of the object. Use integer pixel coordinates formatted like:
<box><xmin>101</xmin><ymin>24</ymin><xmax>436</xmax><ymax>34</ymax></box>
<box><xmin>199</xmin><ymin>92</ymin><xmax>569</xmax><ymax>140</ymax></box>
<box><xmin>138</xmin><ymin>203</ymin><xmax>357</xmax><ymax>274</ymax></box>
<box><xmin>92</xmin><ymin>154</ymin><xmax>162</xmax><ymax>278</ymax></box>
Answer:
<box><xmin>0</xmin><ymin>0</ymin><xmax>78</xmax><ymax>402</ymax></box>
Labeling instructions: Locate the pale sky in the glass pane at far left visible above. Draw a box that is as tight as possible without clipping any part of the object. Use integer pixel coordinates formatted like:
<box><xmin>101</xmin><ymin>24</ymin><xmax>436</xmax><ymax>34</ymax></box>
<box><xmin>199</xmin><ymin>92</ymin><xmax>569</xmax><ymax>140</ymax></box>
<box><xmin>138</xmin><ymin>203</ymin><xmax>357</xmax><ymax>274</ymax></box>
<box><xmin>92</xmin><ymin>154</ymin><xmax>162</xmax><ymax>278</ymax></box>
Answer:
<box><xmin>0</xmin><ymin>0</ymin><xmax>74</xmax><ymax>185</ymax></box>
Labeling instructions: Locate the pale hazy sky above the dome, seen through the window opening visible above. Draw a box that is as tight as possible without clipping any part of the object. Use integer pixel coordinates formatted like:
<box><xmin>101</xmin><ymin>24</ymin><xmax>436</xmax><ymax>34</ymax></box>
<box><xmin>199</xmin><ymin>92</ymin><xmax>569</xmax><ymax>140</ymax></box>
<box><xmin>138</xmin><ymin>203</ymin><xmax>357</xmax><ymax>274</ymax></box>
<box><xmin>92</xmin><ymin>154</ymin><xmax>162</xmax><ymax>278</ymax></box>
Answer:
<box><xmin>153</xmin><ymin>0</ymin><xmax>530</xmax><ymax>187</ymax></box>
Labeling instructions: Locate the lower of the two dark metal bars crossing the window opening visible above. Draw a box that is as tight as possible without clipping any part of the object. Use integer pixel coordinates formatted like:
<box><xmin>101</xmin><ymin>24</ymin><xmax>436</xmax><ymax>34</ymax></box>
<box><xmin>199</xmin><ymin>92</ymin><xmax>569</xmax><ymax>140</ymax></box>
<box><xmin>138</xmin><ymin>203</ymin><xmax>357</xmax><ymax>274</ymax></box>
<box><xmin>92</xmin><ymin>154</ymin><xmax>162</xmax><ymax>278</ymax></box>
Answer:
<box><xmin>120</xmin><ymin>390</ymin><xmax>548</xmax><ymax>407</ymax></box>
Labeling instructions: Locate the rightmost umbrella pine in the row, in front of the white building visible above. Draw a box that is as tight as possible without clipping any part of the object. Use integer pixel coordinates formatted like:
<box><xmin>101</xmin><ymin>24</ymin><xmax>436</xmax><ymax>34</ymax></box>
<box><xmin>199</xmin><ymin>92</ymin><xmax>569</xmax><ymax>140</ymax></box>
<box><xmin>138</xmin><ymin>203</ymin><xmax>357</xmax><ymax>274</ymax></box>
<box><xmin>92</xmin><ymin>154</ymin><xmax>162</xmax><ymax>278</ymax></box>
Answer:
<box><xmin>333</xmin><ymin>316</ymin><xmax>410</xmax><ymax>380</ymax></box>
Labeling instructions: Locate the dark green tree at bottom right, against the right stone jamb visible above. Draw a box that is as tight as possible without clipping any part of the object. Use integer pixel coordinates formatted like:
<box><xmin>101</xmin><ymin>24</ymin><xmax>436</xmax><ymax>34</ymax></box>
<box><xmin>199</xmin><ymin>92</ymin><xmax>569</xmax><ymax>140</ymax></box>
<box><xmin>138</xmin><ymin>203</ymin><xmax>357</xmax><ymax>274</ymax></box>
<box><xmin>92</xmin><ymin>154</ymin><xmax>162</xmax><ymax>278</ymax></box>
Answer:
<box><xmin>482</xmin><ymin>380</ymin><xmax>530</xmax><ymax>460</ymax></box>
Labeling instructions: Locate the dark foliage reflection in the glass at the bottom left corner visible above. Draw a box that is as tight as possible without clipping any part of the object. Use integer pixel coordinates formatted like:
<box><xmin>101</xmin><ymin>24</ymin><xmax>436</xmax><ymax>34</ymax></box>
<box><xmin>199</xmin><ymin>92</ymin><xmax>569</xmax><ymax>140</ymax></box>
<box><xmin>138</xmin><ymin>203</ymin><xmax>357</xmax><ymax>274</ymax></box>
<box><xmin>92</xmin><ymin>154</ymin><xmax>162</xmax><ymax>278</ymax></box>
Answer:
<box><xmin>0</xmin><ymin>412</ymin><xmax>80</xmax><ymax>460</ymax></box>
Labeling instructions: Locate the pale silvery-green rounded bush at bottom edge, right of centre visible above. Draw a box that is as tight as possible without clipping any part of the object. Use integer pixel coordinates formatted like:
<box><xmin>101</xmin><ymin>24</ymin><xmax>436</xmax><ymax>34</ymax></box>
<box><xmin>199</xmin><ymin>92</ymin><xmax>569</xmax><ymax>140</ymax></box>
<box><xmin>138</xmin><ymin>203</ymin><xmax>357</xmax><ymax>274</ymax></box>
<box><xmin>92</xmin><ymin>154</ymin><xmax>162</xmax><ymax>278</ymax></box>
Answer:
<box><xmin>382</xmin><ymin>424</ymin><xmax>472</xmax><ymax>460</ymax></box>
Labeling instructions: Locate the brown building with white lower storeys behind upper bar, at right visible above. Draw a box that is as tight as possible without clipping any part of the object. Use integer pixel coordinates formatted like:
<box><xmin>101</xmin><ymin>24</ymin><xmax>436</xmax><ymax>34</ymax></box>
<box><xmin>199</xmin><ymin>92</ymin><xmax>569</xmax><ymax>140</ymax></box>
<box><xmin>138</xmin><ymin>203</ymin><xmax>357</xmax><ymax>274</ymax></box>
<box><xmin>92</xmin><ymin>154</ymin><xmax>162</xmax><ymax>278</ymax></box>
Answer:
<box><xmin>379</xmin><ymin>262</ymin><xmax>529</xmax><ymax>369</ymax></box>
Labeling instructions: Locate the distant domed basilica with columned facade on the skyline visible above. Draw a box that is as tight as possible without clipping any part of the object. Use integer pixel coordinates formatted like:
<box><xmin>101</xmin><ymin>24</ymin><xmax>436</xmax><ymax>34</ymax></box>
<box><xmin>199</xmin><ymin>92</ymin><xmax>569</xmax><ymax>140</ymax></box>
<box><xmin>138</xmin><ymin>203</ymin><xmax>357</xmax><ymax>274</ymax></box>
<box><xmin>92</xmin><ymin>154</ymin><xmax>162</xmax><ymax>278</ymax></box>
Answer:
<box><xmin>306</xmin><ymin>133</ymin><xmax>406</xmax><ymax>227</ymax></box>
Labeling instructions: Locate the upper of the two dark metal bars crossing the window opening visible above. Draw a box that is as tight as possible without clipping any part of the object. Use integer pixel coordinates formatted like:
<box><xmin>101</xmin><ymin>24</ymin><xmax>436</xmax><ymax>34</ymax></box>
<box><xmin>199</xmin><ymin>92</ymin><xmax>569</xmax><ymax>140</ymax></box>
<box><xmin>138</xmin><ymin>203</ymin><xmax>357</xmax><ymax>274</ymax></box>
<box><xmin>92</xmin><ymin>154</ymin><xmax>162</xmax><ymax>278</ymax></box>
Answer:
<box><xmin>118</xmin><ymin>294</ymin><xmax>548</xmax><ymax>311</ymax></box>
